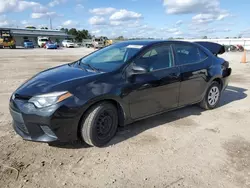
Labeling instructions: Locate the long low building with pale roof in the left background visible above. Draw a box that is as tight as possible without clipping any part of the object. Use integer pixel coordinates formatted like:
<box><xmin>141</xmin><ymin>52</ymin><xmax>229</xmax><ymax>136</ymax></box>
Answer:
<box><xmin>0</xmin><ymin>27</ymin><xmax>72</xmax><ymax>46</ymax></box>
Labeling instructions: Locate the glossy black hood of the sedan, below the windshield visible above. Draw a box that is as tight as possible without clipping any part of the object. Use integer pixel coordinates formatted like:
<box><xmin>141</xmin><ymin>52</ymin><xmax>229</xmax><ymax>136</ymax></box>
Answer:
<box><xmin>15</xmin><ymin>65</ymin><xmax>101</xmax><ymax>97</ymax></box>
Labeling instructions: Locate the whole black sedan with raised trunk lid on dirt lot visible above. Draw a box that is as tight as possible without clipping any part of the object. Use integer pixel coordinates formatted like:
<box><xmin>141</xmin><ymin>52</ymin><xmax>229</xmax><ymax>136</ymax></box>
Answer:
<box><xmin>10</xmin><ymin>40</ymin><xmax>231</xmax><ymax>147</ymax></box>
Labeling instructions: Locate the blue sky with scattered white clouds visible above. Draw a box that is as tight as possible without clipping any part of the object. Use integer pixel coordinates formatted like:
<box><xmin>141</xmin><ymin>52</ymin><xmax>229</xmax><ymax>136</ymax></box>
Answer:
<box><xmin>0</xmin><ymin>0</ymin><xmax>250</xmax><ymax>38</ymax></box>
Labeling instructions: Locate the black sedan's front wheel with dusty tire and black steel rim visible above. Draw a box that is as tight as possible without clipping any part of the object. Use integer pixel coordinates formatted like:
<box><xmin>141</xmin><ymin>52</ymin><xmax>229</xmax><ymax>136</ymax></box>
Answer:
<box><xmin>80</xmin><ymin>102</ymin><xmax>118</xmax><ymax>147</ymax></box>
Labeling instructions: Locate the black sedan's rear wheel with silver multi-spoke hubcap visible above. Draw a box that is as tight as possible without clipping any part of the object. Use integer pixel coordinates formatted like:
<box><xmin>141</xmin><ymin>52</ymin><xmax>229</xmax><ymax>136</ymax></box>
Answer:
<box><xmin>200</xmin><ymin>81</ymin><xmax>221</xmax><ymax>110</ymax></box>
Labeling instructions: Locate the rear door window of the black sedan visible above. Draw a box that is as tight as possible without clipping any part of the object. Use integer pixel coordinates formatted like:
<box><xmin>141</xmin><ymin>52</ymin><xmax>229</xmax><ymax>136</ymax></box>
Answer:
<box><xmin>174</xmin><ymin>44</ymin><xmax>207</xmax><ymax>65</ymax></box>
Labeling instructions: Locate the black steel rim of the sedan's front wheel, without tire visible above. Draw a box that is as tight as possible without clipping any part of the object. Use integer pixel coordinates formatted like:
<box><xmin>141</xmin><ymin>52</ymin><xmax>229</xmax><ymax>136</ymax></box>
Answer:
<box><xmin>96</xmin><ymin>111</ymin><xmax>113</xmax><ymax>139</ymax></box>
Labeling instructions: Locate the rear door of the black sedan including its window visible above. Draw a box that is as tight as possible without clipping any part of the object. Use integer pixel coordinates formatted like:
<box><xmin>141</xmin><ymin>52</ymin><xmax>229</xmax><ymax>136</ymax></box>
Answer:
<box><xmin>174</xmin><ymin>42</ymin><xmax>212</xmax><ymax>106</ymax></box>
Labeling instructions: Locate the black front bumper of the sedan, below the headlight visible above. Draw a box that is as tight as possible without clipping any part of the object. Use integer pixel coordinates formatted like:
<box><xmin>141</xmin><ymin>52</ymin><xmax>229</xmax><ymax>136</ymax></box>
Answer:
<box><xmin>9</xmin><ymin>99</ymin><xmax>81</xmax><ymax>142</ymax></box>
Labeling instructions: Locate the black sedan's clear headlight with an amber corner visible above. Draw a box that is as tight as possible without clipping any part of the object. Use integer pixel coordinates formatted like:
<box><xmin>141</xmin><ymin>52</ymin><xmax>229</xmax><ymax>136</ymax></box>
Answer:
<box><xmin>29</xmin><ymin>91</ymin><xmax>72</xmax><ymax>108</ymax></box>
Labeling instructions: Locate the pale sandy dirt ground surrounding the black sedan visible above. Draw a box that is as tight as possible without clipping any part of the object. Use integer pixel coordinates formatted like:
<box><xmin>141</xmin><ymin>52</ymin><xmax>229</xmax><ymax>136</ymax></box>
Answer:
<box><xmin>0</xmin><ymin>48</ymin><xmax>250</xmax><ymax>188</ymax></box>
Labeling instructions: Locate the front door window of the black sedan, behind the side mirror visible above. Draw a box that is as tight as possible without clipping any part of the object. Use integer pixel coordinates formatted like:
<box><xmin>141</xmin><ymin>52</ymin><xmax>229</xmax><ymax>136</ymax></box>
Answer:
<box><xmin>135</xmin><ymin>44</ymin><xmax>173</xmax><ymax>72</ymax></box>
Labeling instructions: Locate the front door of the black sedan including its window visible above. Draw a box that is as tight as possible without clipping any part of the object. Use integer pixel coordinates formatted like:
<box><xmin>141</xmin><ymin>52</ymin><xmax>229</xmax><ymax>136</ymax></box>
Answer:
<box><xmin>127</xmin><ymin>44</ymin><xmax>180</xmax><ymax>119</ymax></box>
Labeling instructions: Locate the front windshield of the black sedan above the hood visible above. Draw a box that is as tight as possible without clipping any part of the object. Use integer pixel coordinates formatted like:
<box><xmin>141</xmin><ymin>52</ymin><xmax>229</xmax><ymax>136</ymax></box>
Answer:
<box><xmin>80</xmin><ymin>43</ymin><xmax>143</xmax><ymax>72</ymax></box>
